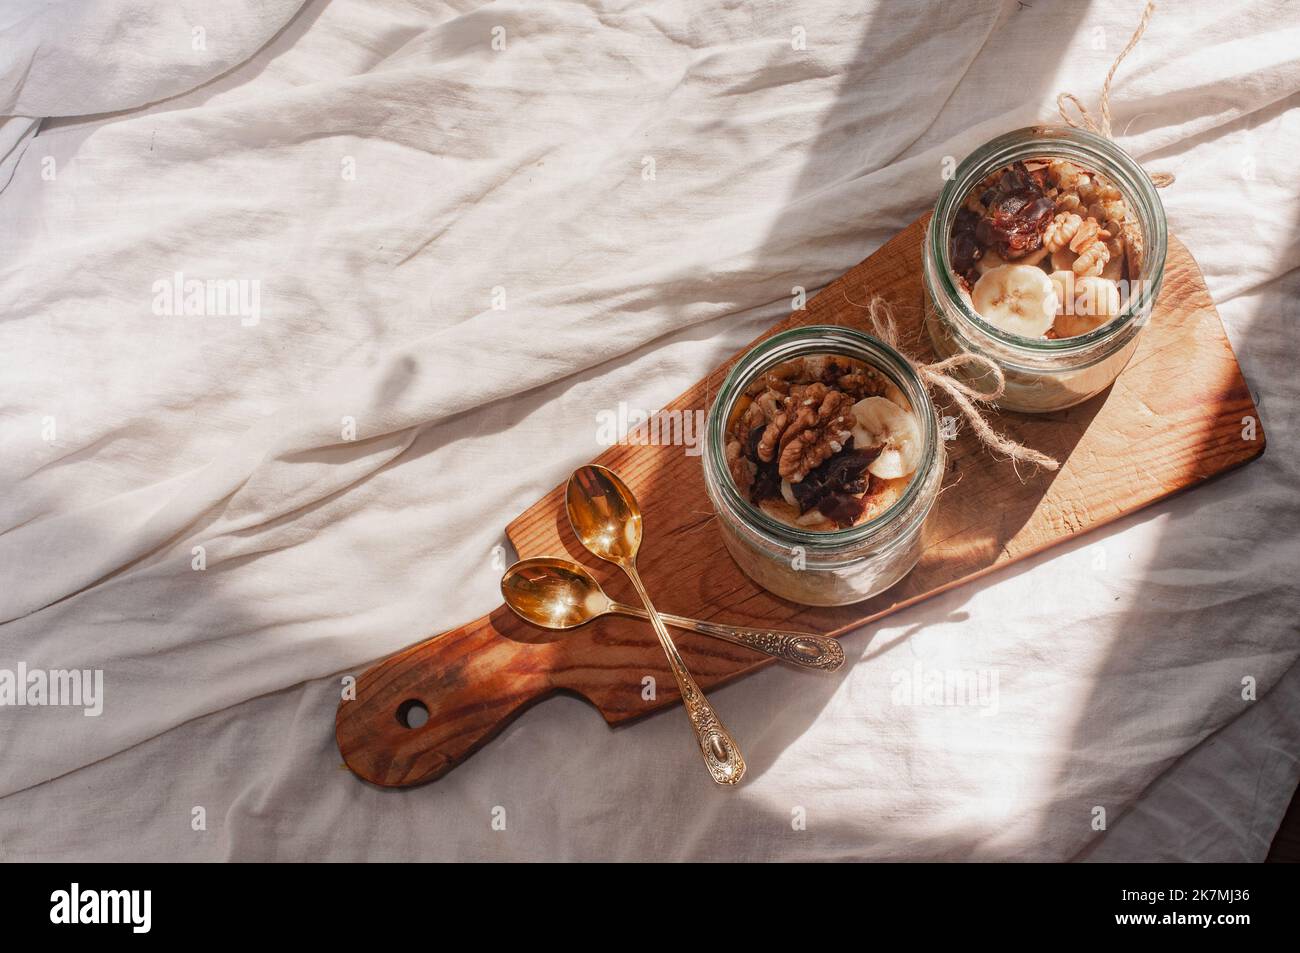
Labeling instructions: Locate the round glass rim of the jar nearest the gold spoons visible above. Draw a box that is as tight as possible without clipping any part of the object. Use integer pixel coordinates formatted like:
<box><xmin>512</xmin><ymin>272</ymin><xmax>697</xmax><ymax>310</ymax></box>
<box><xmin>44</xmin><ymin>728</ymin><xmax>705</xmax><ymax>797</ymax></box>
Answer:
<box><xmin>705</xmin><ymin>324</ymin><xmax>939</xmax><ymax>554</ymax></box>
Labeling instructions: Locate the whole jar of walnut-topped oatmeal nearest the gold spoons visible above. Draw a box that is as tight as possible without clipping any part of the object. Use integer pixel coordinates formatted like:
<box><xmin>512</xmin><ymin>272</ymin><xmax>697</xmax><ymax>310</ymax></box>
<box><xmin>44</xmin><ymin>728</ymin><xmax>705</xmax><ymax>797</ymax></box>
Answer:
<box><xmin>703</xmin><ymin>325</ymin><xmax>944</xmax><ymax>606</ymax></box>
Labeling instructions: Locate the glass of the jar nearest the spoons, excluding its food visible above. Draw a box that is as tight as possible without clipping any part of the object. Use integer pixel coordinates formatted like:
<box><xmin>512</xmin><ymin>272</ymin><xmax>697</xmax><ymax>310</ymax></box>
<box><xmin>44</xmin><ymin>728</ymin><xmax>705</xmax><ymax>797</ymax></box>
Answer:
<box><xmin>703</xmin><ymin>325</ymin><xmax>944</xmax><ymax>606</ymax></box>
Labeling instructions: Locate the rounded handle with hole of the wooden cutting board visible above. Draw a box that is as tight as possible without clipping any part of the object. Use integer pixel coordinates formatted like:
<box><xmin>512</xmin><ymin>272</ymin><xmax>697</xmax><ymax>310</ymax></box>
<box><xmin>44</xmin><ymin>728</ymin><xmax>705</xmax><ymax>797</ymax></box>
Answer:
<box><xmin>334</xmin><ymin>606</ymin><xmax>558</xmax><ymax>787</ymax></box>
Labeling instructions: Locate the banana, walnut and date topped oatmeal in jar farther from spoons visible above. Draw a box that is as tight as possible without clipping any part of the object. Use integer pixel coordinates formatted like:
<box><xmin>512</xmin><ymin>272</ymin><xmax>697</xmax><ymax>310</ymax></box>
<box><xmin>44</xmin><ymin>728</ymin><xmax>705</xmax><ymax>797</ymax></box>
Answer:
<box><xmin>949</xmin><ymin>159</ymin><xmax>1143</xmax><ymax>341</ymax></box>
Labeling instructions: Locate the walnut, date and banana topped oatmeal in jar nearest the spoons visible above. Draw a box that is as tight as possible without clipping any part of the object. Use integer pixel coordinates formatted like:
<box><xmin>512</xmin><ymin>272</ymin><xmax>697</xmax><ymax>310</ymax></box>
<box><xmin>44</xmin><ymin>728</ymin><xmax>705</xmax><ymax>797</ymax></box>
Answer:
<box><xmin>725</xmin><ymin>354</ymin><xmax>923</xmax><ymax>532</ymax></box>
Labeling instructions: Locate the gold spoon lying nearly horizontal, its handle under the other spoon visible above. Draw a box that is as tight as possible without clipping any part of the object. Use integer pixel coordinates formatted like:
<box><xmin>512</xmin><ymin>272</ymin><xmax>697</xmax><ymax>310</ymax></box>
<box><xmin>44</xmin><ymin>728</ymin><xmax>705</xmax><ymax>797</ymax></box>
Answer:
<box><xmin>501</xmin><ymin>556</ymin><xmax>844</xmax><ymax>672</ymax></box>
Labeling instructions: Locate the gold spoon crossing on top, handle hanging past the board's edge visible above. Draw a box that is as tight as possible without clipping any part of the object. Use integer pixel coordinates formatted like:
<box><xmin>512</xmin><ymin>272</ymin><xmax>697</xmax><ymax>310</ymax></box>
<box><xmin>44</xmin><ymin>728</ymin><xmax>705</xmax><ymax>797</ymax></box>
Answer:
<box><xmin>564</xmin><ymin>464</ymin><xmax>745</xmax><ymax>784</ymax></box>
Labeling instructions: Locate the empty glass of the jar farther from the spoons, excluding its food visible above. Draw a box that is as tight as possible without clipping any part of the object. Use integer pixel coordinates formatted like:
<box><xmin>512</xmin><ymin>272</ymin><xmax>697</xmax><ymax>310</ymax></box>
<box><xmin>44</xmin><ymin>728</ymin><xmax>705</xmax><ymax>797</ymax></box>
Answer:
<box><xmin>923</xmin><ymin>126</ymin><xmax>1166</xmax><ymax>413</ymax></box>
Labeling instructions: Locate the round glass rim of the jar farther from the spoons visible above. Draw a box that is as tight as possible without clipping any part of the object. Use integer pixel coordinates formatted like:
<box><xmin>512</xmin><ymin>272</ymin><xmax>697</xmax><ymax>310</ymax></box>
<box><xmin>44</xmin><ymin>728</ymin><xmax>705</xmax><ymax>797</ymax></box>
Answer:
<box><xmin>923</xmin><ymin>125</ymin><xmax>1167</xmax><ymax>358</ymax></box>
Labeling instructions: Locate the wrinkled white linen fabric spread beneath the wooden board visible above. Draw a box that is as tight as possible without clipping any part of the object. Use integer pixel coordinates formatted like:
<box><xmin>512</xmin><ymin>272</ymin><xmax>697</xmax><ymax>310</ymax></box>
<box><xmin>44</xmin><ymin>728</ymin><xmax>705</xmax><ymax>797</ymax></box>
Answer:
<box><xmin>0</xmin><ymin>0</ymin><xmax>1300</xmax><ymax>859</ymax></box>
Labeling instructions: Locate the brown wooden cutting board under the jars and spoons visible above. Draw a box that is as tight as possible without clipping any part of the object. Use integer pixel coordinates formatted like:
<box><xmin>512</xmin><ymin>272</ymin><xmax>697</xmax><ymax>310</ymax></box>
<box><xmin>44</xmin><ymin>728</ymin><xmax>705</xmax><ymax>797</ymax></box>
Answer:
<box><xmin>335</xmin><ymin>217</ymin><xmax>1264</xmax><ymax>787</ymax></box>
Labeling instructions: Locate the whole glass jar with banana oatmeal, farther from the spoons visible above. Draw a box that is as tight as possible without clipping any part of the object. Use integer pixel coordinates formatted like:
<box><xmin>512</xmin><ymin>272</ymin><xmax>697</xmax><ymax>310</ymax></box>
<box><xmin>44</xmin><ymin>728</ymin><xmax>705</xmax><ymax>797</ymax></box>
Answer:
<box><xmin>923</xmin><ymin>126</ymin><xmax>1166</xmax><ymax>413</ymax></box>
